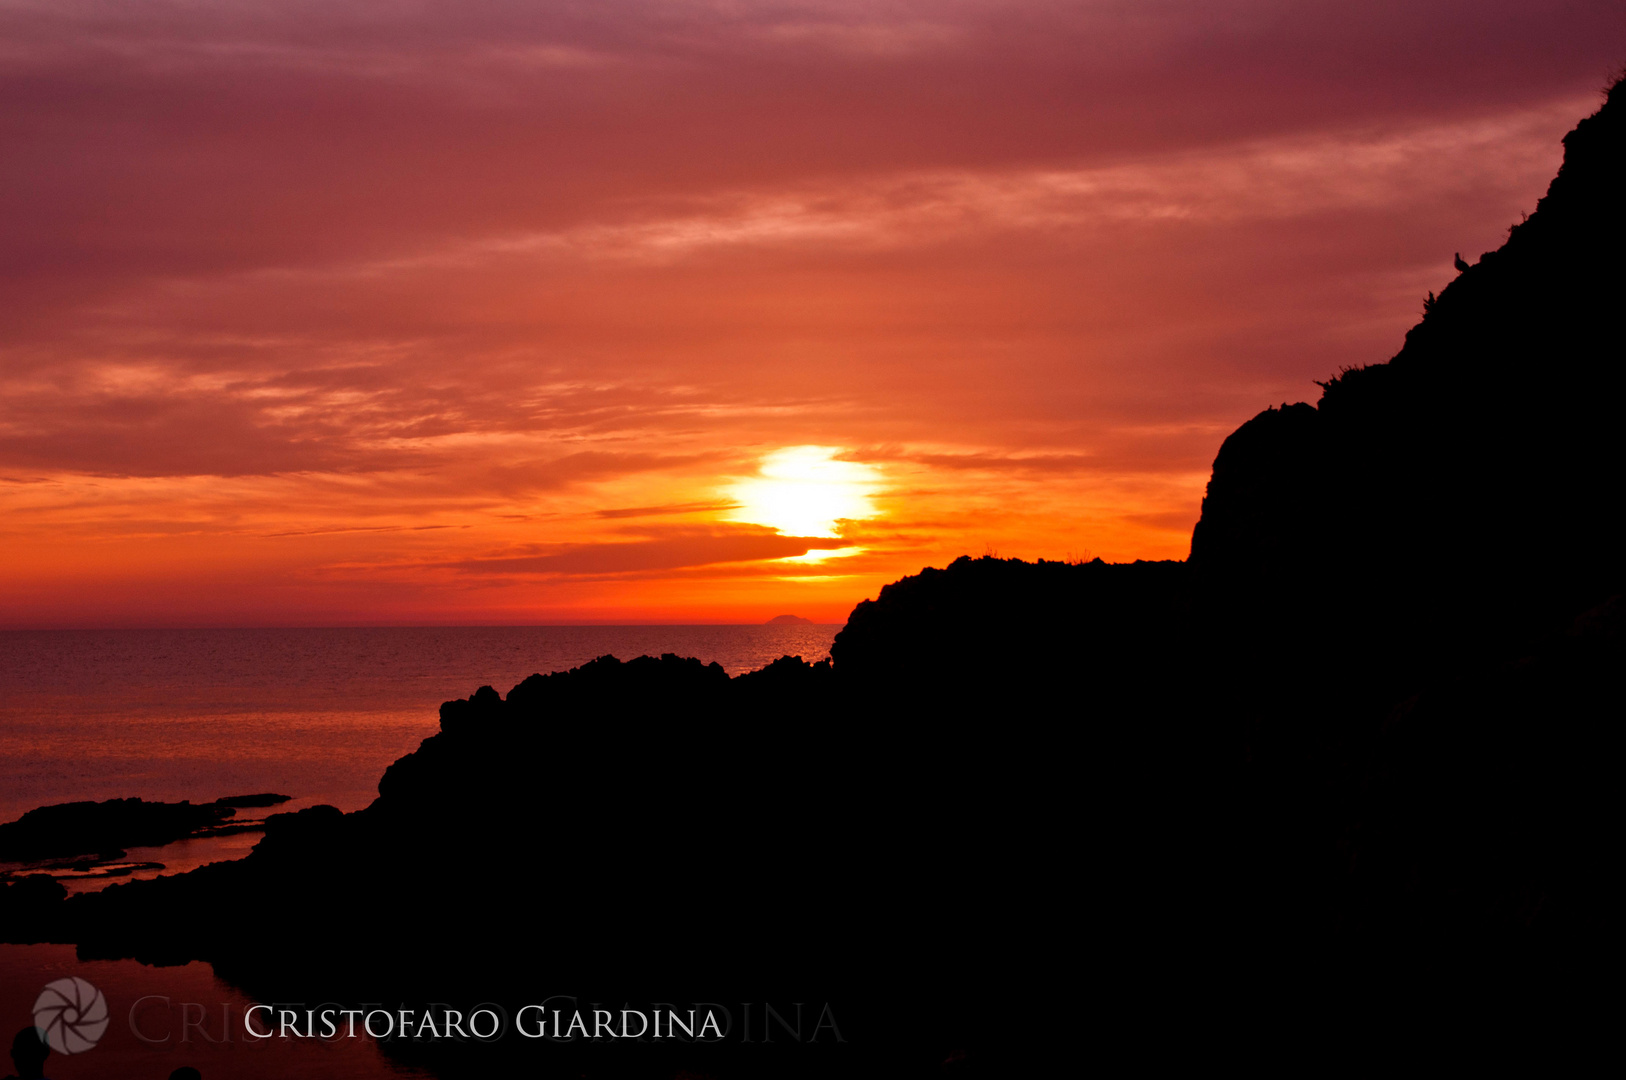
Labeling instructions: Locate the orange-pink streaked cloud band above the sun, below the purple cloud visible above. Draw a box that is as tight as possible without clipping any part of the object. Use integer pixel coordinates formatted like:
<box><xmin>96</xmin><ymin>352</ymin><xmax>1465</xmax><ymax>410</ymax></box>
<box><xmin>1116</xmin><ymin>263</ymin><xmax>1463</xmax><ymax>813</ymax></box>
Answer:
<box><xmin>0</xmin><ymin>87</ymin><xmax>1582</xmax><ymax>490</ymax></box>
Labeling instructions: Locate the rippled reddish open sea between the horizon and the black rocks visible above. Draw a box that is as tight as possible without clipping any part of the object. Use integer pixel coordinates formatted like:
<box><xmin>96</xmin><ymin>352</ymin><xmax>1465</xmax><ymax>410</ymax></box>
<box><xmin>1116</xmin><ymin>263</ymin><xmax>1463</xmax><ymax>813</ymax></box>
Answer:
<box><xmin>0</xmin><ymin>625</ymin><xmax>841</xmax><ymax>826</ymax></box>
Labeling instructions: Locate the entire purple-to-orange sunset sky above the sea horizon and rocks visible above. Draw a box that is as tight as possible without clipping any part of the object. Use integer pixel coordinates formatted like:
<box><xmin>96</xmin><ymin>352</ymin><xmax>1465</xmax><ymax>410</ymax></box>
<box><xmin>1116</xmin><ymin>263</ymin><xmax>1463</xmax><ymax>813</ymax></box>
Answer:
<box><xmin>0</xmin><ymin>0</ymin><xmax>1626</xmax><ymax>626</ymax></box>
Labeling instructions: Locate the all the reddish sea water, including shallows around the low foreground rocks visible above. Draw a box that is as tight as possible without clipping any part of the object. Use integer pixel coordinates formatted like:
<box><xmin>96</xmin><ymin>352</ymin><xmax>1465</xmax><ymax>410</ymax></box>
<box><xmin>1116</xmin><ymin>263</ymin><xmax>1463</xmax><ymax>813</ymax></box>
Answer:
<box><xmin>0</xmin><ymin>623</ymin><xmax>841</xmax><ymax>1080</ymax></box>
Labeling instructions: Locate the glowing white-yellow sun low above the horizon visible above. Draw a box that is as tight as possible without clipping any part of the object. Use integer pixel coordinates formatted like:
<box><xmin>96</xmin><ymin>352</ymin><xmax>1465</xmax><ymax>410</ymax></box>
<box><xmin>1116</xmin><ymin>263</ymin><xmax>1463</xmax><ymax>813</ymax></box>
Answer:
<box><xmin>728</xmin><ymin>446</ymin><xmax>880</xmax><ymax>537</ymax></box>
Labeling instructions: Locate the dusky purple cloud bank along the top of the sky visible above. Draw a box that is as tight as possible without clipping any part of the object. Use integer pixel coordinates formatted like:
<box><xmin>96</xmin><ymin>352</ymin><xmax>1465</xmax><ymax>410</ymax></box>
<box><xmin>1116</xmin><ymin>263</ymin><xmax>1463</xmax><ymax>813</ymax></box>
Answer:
<box><xmin>0</xmin><ymin>0</ymin><xmax>1621</xmax><ymax>307</ymax></box>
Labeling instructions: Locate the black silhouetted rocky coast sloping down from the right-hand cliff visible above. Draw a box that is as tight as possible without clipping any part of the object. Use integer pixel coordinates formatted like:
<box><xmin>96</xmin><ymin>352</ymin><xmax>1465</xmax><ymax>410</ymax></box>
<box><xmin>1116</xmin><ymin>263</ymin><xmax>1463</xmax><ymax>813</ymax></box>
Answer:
<box><xmin>0</xmin><ymin>83</ymin><xmax>1626</xmax><ymax>1078</ymax></box>
